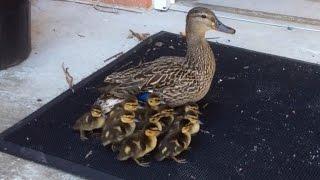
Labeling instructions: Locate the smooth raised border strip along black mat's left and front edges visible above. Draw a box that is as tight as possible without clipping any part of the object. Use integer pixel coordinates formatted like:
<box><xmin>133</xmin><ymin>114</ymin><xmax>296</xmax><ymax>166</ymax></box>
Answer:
<box><xmin>0</xmin><ymin>31</ymin><xmax>168</xmax><ymax>179</ymax></box>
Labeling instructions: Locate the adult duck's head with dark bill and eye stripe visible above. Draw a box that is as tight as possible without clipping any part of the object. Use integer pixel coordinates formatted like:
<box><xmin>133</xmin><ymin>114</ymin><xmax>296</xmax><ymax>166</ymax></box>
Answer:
<box><xmin>186</xmin><ymin>7</ymin><xmax>236</xmax><ymax>35</ymax></box>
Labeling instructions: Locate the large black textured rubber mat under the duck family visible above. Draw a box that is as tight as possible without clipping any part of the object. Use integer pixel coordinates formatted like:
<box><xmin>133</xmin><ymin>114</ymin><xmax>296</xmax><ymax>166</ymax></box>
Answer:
<box><xmin>0</xmin><ymin>32</ymin><xmax>320</xmax><ymax>180</ymax></box>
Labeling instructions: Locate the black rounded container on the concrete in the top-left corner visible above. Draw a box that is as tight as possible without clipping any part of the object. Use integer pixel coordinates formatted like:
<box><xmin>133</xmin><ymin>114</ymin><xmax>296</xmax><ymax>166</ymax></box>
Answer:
<box><xmin>0</xmin><ymin>0</ymin><xmax>31</xmax><ymax>69</ymax></box>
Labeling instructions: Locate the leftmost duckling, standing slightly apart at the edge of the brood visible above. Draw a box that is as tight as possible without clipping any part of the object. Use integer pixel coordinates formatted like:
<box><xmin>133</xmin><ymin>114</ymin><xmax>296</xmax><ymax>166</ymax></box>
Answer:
<box><xmin>73</xmin><ymin>106</ymin><xmax>105</xmax><ymax>140</ymax></box>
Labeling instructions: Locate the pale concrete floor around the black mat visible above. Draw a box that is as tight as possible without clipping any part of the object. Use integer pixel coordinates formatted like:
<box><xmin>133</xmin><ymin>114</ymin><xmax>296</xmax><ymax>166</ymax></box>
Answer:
<box><xmin>0</xmin><ymin>0</ymin><xmax>320</xmax><ymax>179</ymax></box>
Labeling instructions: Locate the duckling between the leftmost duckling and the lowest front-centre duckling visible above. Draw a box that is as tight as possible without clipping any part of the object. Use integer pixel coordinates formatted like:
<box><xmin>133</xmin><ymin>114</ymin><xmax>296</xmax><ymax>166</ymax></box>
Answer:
<box><xmin>101</xmin><ymin>111</ymin><xmax>136</xmax><ymax>146</ymax></box>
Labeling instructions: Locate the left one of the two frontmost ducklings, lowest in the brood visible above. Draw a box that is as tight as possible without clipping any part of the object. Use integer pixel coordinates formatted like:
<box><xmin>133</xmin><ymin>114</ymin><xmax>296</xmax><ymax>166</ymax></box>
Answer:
<box><xmin>117</xmin><ymin>122</ymin><xmax>162</xmax><ymax>167</ymax></box>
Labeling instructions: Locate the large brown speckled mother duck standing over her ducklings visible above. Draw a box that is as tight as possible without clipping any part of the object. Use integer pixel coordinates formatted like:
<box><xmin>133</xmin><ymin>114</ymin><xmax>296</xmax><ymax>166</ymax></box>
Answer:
<box><xmin>96</xmin><ymin>7</ymin><xmax>235</xmax><ymax>112</ymax></box>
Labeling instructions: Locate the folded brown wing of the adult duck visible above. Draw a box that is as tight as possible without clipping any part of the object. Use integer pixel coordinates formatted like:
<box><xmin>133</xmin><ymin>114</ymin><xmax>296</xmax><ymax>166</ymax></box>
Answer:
<box><xmin>104</xmin><ymin>56</ymin><xmax>185</xmax><ymax>90</ymax></box>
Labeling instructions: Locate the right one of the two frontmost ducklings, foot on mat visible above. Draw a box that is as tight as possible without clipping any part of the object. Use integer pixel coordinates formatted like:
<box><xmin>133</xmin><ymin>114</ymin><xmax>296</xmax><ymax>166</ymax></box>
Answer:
<box><xmin>155</xmin><ymin>120</ymin><xmax>192</xmax><ymax>163</ymax></box>
